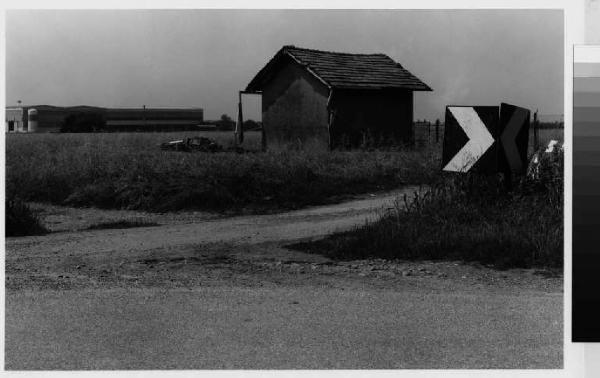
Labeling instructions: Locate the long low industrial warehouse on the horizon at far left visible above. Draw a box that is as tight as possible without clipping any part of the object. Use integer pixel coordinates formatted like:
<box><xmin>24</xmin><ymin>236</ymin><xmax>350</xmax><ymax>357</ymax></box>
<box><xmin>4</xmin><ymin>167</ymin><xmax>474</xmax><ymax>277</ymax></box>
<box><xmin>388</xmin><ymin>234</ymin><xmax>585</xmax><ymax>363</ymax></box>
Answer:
<box><xmin>6</xmin><ymin>105</ymin><xmax>204</xmax><ymax>133</ymax></box>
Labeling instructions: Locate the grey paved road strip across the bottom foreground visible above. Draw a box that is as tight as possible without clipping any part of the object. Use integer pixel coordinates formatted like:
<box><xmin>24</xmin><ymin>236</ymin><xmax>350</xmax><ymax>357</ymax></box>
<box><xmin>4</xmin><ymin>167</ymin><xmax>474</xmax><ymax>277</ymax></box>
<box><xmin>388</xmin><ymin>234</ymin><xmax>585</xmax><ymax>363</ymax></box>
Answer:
<box><xmin>6</xmin><ymin>287</ymin><xmax>562</xmax><ymax>369</ymax></box>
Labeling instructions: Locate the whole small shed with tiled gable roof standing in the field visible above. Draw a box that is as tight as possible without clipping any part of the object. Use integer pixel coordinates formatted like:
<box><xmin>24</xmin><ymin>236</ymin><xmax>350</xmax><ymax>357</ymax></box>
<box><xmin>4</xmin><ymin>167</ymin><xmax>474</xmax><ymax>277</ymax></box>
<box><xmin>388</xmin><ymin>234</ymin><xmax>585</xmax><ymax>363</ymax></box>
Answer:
<box><xmin>243</xmin><ymin>46</ymin><xmax>431</xmax><ymax>148</ymax></box>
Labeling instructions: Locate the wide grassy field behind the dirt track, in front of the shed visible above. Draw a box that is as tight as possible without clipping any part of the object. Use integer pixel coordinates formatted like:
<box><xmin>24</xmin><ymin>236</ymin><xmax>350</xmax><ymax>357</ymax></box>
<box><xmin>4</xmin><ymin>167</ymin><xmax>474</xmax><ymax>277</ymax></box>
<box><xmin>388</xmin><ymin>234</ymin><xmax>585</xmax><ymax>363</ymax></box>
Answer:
<box><xmin>6</xmin><ymin>132</ymin><xmax>439</xmax><ymax>213</ymax></box>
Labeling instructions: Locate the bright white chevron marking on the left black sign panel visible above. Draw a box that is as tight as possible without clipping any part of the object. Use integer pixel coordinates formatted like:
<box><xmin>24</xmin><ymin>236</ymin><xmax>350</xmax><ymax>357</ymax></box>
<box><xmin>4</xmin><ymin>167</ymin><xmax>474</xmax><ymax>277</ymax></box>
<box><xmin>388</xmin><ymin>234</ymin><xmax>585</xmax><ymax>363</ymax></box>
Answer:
<box><xmin>443</xmin><ymin>107</ymin><xmax>494</xmax><ymax>172</ymax></box>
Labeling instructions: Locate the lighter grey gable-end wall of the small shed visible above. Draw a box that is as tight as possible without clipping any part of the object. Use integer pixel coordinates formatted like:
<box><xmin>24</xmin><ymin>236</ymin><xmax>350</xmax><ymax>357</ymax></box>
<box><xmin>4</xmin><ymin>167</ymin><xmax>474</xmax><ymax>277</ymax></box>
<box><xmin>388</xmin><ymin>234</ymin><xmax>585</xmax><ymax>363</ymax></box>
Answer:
<box><xmin>262</xmin><ymin>62</ymin><xmax>329</xmax><ymax>149</ymax></box>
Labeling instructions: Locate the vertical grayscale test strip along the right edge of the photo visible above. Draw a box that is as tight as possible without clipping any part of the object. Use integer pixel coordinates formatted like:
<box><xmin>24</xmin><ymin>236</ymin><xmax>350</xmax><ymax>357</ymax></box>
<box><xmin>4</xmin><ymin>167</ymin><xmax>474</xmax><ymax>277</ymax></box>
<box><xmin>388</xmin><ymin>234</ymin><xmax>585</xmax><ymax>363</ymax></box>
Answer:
<box><xmin>572</xmin><ymin>46</ymin><xmax>600</xmax><ymax>342</ymax></box>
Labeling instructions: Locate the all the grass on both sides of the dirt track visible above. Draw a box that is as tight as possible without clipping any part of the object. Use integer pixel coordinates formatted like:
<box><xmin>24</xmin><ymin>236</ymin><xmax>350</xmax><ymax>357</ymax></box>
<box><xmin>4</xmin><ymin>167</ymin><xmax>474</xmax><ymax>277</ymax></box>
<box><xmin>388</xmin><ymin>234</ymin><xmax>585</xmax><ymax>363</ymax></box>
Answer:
<box><xmin>6</xmin><ymin>130</ymin><xmax>563</xmax><ymax>268</ymax></box>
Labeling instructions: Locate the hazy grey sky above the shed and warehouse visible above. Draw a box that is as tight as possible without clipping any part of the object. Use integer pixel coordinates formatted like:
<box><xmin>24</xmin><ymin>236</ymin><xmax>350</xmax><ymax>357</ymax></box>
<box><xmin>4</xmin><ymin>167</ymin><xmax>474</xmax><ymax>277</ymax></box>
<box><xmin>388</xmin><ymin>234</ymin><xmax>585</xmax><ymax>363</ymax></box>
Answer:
<box><xmin>6</xmin><ymin>10</ymin><xmax>564</xmax><ymax>120</ymax></box>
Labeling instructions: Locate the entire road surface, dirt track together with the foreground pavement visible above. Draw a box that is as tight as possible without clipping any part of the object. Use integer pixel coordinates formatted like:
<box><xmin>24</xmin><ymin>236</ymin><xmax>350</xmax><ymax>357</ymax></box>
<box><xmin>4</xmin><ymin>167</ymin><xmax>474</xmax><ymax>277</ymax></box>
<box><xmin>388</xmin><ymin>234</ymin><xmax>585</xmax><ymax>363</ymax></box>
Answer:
<box><xmin>5</xmin><ymin>188</ymin><xmax>563</xmax><ymax>370</ymax></box>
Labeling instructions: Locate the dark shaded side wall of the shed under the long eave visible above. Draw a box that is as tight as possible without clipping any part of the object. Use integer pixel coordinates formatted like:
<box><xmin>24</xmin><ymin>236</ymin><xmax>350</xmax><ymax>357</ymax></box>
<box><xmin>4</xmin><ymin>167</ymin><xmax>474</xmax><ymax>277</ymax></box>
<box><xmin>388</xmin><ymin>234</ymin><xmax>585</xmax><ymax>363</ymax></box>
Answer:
<box><xmin>331</xmin><ymin>90</ymin><xmax>413</xmax><ymax>147</ymax></box>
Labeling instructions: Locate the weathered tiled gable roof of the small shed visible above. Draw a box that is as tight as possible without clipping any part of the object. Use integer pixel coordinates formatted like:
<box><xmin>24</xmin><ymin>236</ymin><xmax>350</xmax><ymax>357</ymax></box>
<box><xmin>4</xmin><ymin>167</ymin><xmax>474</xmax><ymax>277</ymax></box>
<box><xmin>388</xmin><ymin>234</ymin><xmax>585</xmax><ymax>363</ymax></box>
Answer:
<box><xmin>246</xmin><ymin>46</ymin><xmax>431</xmax><ymax>91</ymax></box>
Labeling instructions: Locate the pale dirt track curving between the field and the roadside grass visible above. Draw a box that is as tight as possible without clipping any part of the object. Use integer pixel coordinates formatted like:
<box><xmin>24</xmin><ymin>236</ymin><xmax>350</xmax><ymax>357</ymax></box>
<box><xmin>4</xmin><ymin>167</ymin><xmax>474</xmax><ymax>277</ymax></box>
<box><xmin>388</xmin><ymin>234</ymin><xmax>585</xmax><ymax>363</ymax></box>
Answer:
<box><xmin>6</xmin><ymin>187</ymin><xmax>418</xmax><ymax>254</ymax></box>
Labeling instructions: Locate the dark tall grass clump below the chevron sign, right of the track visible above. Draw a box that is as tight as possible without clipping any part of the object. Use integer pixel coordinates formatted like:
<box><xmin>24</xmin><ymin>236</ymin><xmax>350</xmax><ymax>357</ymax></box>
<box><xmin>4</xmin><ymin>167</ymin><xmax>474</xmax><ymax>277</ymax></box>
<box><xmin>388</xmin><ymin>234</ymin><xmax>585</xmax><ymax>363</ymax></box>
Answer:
<box><xmin>293</xmin><ymin>148</ymin><xmax>563</xmax><ymax>268</ymax></box>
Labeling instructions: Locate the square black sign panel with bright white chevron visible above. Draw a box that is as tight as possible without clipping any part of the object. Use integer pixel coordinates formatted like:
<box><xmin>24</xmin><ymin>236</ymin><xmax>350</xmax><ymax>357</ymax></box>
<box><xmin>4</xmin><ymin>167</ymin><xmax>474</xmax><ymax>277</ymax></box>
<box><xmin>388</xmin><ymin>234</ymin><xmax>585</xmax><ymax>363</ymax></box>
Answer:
<box><xmin>442</xmin><ymin>106</ymin><xmax>498</xmax><ymax>172</ymax></box>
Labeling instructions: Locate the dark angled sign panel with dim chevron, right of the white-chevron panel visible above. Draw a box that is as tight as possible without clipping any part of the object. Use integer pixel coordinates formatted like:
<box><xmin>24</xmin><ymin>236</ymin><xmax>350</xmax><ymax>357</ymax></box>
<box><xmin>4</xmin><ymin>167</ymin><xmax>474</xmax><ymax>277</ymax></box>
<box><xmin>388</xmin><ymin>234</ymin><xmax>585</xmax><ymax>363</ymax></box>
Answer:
<box><xmin>499</xmin><ymin>103</ymin><xmax>530</xmax><ymax>173</ymax></box>
